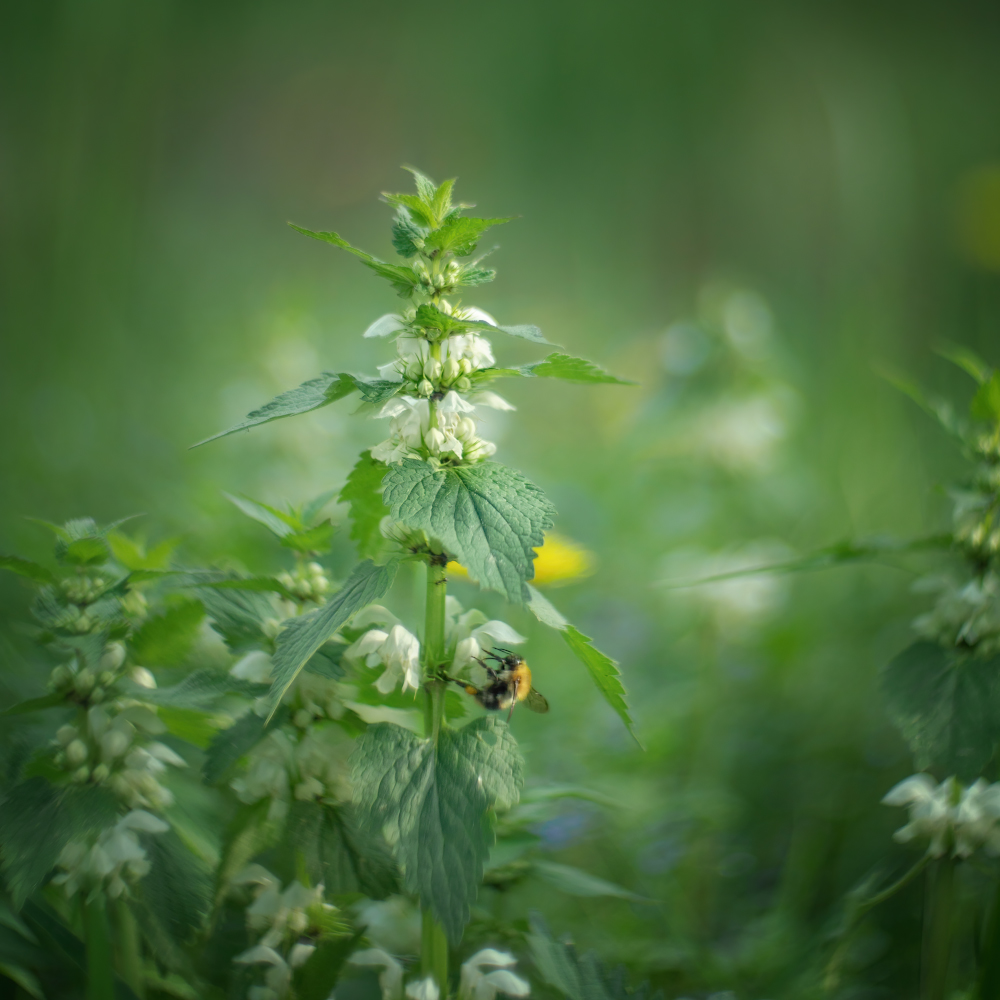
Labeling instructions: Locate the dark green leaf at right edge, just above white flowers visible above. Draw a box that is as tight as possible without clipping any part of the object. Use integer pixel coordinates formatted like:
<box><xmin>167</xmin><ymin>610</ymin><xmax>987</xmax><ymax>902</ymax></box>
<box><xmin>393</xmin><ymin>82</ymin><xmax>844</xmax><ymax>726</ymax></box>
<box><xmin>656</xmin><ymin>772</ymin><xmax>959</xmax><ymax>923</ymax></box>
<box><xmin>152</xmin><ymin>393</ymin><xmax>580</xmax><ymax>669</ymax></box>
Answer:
<box><xmin>882</xmin><ymin>642</ymin><xmax>1000</xmax><ymax>781</ymax></box>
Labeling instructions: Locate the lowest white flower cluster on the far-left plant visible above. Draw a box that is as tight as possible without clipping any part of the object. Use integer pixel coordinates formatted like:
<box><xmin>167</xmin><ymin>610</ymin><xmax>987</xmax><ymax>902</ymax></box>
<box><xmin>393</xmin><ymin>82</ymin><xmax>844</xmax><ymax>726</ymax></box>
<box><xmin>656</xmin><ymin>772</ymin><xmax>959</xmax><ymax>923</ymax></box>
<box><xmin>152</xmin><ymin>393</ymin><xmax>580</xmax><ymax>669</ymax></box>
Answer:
<box><xmin>52</xmin><ymin>809</ymin><xmax>170</xmax><ymax>899</ymax></box>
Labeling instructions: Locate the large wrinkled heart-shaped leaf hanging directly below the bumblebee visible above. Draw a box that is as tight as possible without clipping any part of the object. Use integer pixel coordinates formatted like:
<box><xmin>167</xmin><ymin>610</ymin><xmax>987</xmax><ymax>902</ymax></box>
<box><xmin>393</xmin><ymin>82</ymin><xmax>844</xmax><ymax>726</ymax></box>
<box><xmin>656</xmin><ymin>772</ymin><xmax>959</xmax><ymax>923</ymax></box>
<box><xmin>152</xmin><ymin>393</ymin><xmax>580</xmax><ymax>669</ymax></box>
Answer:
<box><xmin>351</xmin><ymin>716</ymin><xmax>523</xmax><ymax>945</ymax></box>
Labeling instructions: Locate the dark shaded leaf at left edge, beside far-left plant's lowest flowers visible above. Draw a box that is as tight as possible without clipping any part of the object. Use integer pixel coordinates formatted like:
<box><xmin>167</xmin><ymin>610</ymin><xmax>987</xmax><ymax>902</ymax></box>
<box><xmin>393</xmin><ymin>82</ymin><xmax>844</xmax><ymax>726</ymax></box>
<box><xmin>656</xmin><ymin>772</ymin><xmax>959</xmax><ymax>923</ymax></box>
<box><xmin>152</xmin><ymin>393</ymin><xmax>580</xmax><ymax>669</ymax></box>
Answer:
<box><xmin>0</xmin><ymin>778</ymin><xmax>118</xmax><ymax>908</ymax></box>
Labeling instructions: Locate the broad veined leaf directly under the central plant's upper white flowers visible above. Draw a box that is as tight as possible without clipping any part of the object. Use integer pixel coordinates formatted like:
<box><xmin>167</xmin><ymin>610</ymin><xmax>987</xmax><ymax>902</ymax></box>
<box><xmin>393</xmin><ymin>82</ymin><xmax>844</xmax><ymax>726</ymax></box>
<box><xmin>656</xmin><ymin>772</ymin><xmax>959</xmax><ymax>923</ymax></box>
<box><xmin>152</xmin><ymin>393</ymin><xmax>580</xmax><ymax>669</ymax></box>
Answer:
<box><xmin>382</xmin><ymin>459</ymin><xmax>556</xmax><ymax>604</ymax></box>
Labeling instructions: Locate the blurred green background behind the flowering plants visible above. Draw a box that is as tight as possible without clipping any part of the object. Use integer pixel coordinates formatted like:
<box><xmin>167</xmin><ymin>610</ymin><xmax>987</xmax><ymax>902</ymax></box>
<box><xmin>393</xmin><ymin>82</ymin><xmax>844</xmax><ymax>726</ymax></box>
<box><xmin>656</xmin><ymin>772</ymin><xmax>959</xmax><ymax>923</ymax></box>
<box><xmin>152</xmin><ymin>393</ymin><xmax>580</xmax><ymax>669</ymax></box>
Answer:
<box><xmin>0</xmin><ymin>0</ymin><xmax>1000</xmax><ymax>997</ymax></box>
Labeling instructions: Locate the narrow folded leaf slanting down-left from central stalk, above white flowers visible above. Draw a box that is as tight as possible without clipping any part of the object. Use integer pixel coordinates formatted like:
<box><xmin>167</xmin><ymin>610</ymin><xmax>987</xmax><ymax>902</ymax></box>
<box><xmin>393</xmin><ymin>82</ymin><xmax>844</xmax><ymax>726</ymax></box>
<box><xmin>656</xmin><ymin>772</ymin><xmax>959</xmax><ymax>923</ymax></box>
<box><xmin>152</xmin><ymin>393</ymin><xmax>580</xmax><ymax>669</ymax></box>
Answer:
<box><xmin>268</xmin><ymin>560</ymin><xmax>399</xmax><ymax>714</ymax></box>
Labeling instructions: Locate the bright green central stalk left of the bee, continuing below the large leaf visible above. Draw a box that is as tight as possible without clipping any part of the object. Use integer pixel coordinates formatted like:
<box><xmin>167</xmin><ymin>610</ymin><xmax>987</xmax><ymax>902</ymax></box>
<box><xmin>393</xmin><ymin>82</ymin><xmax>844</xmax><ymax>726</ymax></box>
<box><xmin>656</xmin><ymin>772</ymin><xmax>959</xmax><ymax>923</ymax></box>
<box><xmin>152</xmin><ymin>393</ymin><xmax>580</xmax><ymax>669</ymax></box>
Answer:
<box><xmin>420</xmin><ymin>561</ymin><xmax>448</xmax><ymax>997</ymax></box>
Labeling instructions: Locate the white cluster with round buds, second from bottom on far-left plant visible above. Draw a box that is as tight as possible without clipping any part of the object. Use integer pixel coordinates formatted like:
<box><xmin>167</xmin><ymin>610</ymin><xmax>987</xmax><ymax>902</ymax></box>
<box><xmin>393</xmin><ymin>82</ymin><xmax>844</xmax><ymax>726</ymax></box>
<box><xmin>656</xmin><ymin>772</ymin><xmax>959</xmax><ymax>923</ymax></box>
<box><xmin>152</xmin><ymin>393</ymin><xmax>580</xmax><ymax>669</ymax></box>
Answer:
<box><xmin>54</xmin><ymin>699</ymin><xmax>187</xmax><ymax>810</ymax></box>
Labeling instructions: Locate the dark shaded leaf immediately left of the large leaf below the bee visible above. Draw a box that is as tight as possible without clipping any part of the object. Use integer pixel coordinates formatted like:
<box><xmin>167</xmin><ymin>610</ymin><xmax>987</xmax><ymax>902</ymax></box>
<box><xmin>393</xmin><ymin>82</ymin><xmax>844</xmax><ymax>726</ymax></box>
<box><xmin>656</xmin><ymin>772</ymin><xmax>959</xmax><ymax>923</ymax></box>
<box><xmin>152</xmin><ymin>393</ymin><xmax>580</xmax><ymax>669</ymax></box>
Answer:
<box><xmin>286</xmin><ymin>802</ymin><xmax>399</xmax><ymax>899</ymax></box>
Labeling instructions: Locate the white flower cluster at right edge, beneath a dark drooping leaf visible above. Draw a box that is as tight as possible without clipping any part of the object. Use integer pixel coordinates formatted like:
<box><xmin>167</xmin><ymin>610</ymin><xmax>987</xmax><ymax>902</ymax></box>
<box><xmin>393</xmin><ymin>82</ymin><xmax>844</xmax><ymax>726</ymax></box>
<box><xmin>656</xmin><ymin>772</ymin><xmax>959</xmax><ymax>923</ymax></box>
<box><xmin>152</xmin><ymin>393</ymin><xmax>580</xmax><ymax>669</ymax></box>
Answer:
<box><xmin>882</xmin><ymin>774</ymin><xmax>1000</xmax><ymax>858</ymax></box>
